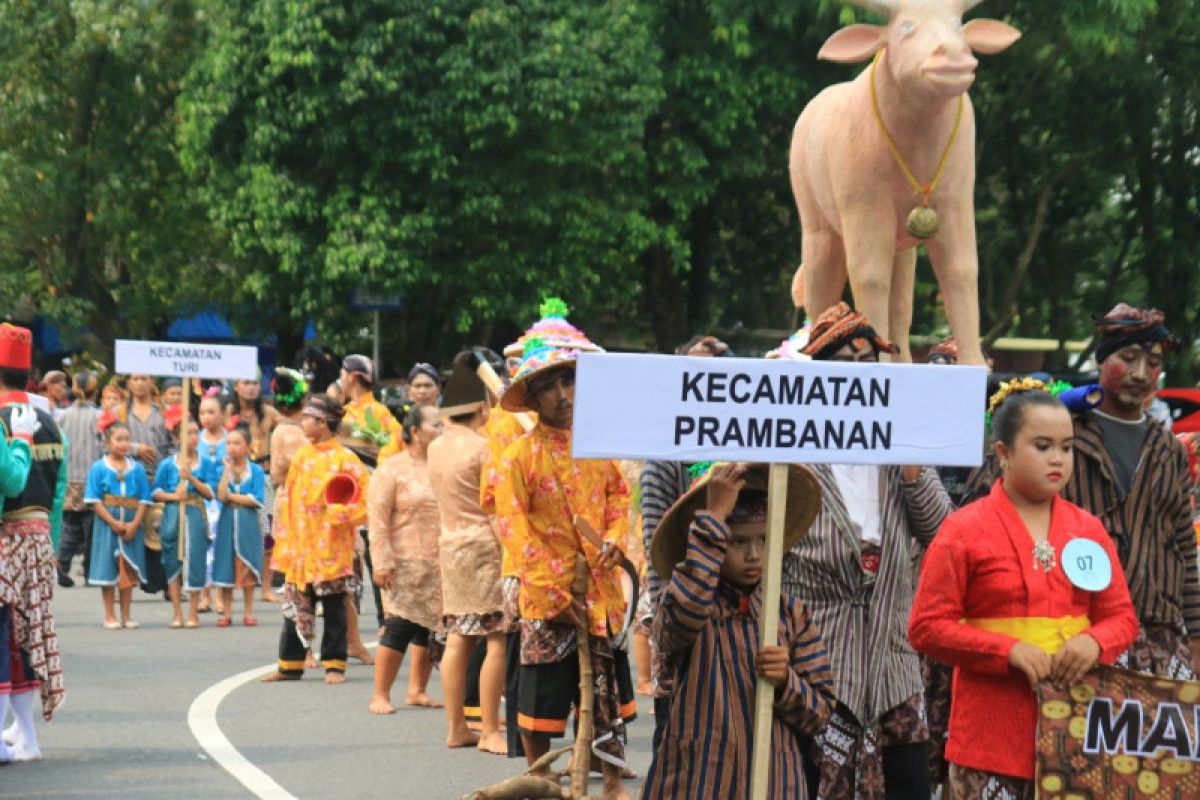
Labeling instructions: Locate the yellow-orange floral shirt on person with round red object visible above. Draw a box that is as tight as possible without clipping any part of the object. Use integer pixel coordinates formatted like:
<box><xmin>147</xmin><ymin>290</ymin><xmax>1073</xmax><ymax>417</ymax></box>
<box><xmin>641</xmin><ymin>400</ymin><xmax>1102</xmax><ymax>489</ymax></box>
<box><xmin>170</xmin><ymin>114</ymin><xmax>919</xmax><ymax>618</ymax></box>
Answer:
<box><xmin>271</xmin><ymin>439</ymin><xmax>368</xmax><ymax>588</ymax></box>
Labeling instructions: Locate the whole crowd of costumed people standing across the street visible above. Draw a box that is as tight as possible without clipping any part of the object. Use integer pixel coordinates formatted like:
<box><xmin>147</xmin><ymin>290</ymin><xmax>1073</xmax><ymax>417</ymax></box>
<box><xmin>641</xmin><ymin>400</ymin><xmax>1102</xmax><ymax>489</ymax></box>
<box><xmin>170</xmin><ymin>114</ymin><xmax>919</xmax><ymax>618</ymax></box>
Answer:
<box><xmin>0</xmin><ymin>301</ymin><xmax>1200</xmax><ymax>800</ymax></box>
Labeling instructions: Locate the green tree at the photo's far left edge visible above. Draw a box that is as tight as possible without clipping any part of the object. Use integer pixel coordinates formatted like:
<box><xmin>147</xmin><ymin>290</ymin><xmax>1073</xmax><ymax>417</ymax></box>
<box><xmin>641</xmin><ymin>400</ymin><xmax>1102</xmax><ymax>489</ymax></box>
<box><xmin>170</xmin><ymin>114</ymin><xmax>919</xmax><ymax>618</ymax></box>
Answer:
<box><xmin>0</xmin><ymin>0</ymin><xmax>223</xmax><ymax>351</ymax></box>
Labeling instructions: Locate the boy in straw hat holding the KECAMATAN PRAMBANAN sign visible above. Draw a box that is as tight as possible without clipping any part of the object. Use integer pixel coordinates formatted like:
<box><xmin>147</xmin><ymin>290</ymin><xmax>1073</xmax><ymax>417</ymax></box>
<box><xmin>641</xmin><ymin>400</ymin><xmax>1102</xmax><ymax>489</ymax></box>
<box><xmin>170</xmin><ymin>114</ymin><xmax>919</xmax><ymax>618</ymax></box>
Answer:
<box><xmin>642</xmin><ymin>464</ymin><xmax>834</xmax><ymax>800</ymax></box>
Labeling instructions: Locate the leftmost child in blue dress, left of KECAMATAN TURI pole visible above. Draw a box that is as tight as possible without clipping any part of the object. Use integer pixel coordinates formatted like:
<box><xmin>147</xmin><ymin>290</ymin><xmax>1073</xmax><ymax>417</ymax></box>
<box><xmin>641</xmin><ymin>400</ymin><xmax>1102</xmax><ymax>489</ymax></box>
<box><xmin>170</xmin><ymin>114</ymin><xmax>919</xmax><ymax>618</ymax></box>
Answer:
<box><xmin>83</xmin><ymin>421</ymin><xmax>151</xmax><ymax>630</ymax></box>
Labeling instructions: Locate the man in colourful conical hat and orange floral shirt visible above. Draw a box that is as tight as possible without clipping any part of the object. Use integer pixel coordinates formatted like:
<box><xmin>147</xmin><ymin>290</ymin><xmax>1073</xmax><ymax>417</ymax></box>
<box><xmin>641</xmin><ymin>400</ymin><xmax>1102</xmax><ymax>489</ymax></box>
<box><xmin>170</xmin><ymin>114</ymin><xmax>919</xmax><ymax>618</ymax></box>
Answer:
<box><xmin>496</xmin><ymin>333</ymin><xmax>636</xmax><ymax>800</ymax></box>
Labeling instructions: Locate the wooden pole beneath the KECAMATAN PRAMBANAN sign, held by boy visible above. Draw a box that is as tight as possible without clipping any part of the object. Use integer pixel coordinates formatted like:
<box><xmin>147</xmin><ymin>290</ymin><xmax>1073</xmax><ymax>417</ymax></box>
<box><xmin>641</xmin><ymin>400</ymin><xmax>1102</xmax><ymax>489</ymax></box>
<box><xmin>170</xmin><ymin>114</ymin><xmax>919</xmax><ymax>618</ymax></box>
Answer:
<box><xmin>750</xmin><ymin>464</ymin><xmax>788</xmax><ymax>800</ymax></box>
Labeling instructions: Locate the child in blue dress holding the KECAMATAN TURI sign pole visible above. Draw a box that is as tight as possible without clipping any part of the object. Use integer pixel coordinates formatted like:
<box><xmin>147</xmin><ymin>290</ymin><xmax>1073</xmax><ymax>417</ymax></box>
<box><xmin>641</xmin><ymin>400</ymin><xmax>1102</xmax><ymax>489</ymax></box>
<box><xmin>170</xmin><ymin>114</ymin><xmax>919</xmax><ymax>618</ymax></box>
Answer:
<box><xmin>151</xmin><ymin>407</ymin><xmax>215</xmax><ymax>627</ymax></box>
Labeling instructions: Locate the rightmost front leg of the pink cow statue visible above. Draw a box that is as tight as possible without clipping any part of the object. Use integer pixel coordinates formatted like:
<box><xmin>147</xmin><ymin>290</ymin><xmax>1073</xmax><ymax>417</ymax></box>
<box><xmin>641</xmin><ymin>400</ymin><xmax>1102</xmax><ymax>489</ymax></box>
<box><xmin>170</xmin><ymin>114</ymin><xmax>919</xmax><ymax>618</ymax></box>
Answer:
<box><xmin>925</xmin><ymin>206</ymin><xmax>986</xmax><ymax>366</ymax></box>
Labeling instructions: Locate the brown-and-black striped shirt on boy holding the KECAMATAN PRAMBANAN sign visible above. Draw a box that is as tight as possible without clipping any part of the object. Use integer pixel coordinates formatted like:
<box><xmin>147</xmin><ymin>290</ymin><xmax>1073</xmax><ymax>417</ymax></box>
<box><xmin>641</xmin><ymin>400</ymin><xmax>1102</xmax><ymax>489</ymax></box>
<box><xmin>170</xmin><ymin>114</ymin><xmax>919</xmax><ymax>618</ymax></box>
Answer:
<box><xmin>642</xmin><ymin>512</ymin><xmax>834</xmax><ymax>800</ymax></box>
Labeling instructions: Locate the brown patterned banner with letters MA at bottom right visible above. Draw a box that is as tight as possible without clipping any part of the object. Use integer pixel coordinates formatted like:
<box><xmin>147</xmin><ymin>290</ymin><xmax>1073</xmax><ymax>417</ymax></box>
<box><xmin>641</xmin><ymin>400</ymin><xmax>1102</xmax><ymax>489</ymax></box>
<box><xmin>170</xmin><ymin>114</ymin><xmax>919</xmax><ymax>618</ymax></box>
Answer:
<box><xmin>1037</xmin><ymin>667</ymin><xmax>1200</xmax><ymax>800</ymax></box>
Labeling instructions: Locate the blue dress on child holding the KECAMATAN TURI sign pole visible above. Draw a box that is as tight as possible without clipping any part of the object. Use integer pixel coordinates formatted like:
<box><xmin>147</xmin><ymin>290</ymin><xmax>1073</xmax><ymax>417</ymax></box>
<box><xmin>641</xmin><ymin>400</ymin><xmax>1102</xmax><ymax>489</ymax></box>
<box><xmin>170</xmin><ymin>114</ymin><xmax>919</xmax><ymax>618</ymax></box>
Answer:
<box><xmin>151</xmin><ymin>453</ymin><xmax>215</xmax><ymax>591</ymax></box>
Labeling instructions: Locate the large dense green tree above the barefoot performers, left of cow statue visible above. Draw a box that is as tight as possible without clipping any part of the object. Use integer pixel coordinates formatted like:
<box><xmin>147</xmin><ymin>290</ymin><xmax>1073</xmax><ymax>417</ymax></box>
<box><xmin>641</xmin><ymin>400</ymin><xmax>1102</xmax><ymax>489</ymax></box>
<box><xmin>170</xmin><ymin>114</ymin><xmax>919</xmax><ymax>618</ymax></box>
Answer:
<box><xmin>181</xmin><ymin>0</ymin><xmax>659</xmax><ymax>369</ymax></box>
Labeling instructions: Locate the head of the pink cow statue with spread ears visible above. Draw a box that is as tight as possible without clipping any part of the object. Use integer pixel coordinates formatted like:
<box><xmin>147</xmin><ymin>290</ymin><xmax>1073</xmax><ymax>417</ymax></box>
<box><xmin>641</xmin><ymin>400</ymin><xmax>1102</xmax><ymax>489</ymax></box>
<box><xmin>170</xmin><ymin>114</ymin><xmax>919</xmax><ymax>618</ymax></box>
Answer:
<box><xmin>817</xmin><ymin>0</ymin><xmax>1021</xmax><ymax>98</ymax></box>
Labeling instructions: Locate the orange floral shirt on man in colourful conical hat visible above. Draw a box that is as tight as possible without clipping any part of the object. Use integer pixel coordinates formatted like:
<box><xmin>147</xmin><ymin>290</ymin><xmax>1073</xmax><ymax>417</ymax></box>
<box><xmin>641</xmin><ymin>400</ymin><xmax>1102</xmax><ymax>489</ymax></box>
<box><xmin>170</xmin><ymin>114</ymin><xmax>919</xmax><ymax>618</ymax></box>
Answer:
<box><xmin>496</xmin><ymin>423</ymin><xmax>629</xmax><ymax>636</ymax></box>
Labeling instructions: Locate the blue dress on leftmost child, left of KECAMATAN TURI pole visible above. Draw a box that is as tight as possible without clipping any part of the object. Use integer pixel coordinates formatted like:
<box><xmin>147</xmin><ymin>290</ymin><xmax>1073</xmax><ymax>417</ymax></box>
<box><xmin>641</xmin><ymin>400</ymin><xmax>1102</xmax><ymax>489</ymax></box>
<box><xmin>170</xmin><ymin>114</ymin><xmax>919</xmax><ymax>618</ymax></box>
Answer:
<box><xmin>83</xmin><ymin>457</ymin><xmax>152</xmax><ymax>587</ymax></box>
